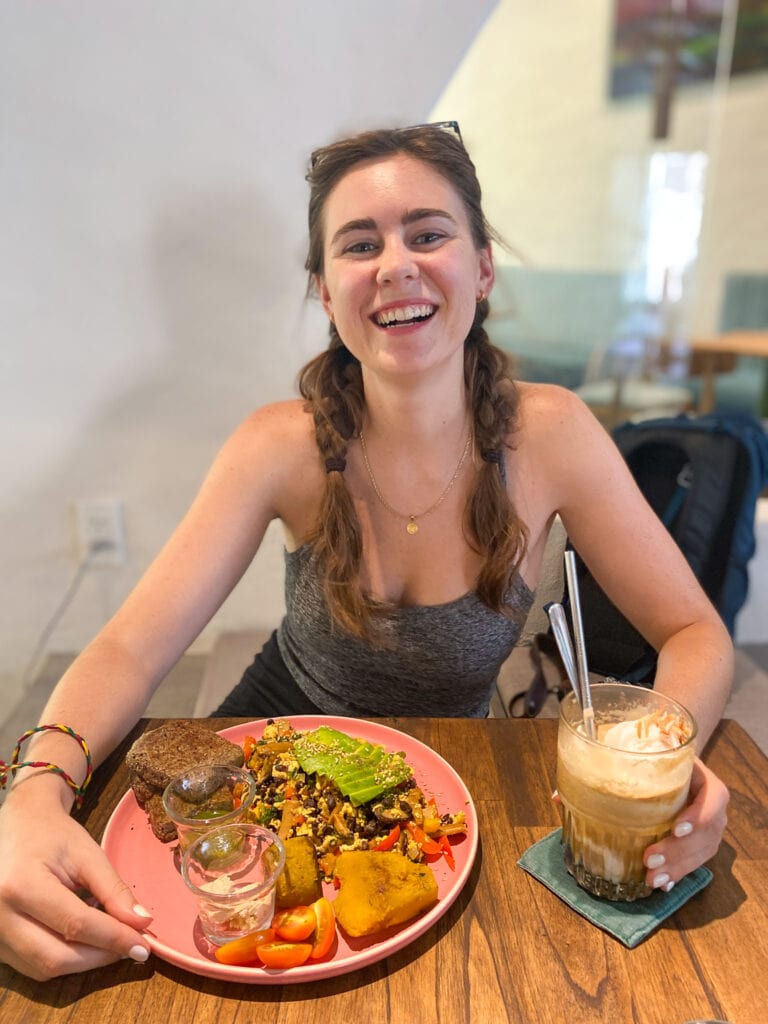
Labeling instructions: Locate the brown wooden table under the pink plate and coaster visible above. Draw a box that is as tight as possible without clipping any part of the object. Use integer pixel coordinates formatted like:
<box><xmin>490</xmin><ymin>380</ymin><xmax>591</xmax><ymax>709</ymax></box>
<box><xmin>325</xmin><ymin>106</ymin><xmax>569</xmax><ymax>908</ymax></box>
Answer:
<box><xmin>0</xmin><ymin>719</ymin><xmax>768</xmax><ymax>1024</ymax></box>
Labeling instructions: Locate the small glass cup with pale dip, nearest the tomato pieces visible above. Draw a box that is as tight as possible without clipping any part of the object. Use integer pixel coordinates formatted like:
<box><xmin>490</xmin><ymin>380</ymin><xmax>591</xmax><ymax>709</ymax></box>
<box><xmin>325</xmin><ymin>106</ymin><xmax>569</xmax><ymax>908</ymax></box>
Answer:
<box><xmin>181</xmin><ymin>821</ymin><xmax>286</xmax><ymax>945</ymax></box>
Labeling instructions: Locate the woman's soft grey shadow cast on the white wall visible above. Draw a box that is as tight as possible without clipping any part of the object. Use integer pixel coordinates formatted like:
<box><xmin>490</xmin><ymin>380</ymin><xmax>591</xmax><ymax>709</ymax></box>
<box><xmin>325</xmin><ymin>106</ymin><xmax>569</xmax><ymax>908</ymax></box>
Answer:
<box><xmin>0</xmin><ymin>190</ymin><xmax>313</xmax><ymax>668</ymax></box>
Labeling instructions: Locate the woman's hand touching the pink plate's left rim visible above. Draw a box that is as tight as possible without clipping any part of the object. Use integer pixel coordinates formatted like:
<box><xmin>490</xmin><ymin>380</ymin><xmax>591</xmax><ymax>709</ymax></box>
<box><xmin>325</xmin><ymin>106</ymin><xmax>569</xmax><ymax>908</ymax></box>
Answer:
<box><xmin>0</xmin><ymin>783</ymin><xmax>152</xmax><ymax>981</ymax></box>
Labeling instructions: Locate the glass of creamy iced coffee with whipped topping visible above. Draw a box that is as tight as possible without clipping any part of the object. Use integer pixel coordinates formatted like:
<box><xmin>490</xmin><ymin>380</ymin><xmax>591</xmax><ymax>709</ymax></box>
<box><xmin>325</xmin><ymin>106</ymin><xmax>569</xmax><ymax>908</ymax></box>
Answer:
<box><xmin>557</xmin><ymin>683</ymin><xmax>696</xmax><ymax>900</ymax></box>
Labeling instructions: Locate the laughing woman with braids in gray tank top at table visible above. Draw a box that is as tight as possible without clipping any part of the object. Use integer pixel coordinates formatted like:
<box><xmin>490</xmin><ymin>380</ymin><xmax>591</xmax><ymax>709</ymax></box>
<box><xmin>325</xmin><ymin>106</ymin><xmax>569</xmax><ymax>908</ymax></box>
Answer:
<box><xmin>0</xmin><ymin>125</ymin><xmax>731</xmax><ymax>977</ymax></box>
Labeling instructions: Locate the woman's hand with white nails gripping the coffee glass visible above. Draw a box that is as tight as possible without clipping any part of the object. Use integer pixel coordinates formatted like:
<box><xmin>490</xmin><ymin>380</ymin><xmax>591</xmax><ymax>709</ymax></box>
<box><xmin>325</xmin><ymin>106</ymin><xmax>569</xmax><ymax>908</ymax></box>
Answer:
<box><xmin>643</xmin><ymin>758</ymin><xmax>729</xmax><ymax>892</ymax></box>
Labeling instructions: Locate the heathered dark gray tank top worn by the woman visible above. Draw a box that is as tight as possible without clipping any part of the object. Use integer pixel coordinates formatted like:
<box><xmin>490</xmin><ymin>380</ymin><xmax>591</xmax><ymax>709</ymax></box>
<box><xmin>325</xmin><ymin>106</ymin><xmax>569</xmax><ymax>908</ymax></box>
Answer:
<box><xmin>278</xmin><ymin>545</ymin><xmax>534</xmax><ymax>718</ymax></box>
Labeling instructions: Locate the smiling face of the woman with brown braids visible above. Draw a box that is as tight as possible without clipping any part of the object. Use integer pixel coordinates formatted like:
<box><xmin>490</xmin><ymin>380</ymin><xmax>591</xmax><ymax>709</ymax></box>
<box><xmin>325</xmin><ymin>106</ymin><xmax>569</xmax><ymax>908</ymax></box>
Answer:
<box><xmin>315</xmin><ymin>155</ymin><xmax>494</xmax><ymax>392</ymax></box>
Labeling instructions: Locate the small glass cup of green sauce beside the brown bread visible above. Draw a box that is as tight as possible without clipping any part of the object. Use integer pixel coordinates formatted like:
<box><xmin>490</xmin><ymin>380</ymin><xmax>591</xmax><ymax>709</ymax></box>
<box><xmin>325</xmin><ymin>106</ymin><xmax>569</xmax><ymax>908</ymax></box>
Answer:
<box><xmin>163</xmin><ymin>765</ymin><xmax>256</xmax><ymax>852</ymax></box>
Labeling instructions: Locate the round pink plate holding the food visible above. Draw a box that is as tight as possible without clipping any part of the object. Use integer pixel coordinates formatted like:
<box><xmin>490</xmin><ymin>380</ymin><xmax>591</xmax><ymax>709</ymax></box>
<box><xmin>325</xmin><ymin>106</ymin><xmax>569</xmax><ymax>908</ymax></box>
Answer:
<box><xmin>101</xmin><ymin>715</ymin><xmax>477</xmax><ymax>985</ymax></box>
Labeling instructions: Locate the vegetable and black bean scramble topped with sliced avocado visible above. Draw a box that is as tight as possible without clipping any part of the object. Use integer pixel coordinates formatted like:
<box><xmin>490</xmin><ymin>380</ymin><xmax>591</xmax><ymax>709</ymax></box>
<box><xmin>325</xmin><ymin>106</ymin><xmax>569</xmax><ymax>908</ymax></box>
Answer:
<box><xmin>244</xmin><ymin>719</ymin><xmax>467</xmax><ymax>881</ymax></box>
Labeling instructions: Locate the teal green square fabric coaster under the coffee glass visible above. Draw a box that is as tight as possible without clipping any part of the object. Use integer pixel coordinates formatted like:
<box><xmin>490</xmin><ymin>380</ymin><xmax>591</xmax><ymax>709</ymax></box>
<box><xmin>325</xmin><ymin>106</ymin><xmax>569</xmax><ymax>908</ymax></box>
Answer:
<box><xmin>517</xmin><ymin>828</ymin><xmax>713</xmax><ymax>949</ymax></box>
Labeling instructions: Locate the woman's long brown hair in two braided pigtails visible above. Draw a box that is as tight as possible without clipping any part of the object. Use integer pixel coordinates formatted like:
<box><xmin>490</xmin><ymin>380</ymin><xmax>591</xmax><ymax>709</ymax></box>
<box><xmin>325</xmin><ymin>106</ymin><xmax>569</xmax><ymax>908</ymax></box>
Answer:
<box><xmin>299</xmin><ymin>126</ymin><xmax>526</xmax><ymax>641</ymax></box>
